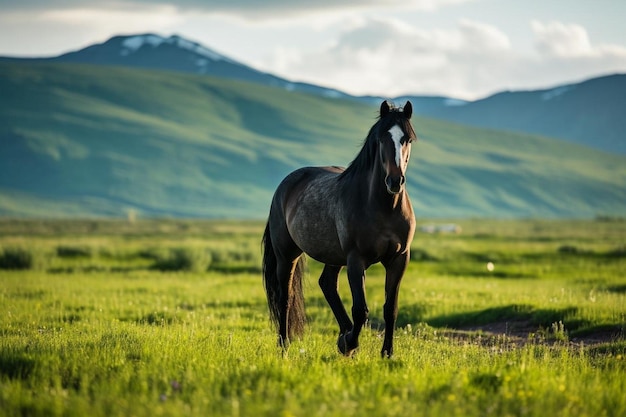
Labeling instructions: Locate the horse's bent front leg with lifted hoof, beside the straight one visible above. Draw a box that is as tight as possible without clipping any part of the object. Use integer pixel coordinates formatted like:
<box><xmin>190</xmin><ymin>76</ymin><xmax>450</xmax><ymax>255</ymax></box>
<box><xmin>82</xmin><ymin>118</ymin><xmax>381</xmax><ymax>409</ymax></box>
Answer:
<box><xmin>337</xmin><ymin>255</ymin><xmax>369</xmax><ymax>356</ymax></box>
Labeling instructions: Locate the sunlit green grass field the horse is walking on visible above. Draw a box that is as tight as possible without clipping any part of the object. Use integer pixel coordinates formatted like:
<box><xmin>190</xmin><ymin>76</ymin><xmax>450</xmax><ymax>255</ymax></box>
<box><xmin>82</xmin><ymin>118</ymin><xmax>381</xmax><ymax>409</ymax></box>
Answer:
<box><xmin>0</xmin><ymin>219</ymin><xmax>626</xmax><ymax>417</ymax></box>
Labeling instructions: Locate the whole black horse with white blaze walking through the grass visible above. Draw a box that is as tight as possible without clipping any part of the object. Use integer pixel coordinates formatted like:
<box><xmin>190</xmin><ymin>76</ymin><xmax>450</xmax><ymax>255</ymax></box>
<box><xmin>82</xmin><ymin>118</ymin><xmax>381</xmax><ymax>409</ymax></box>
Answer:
<box><xmin>262</xmin><ymin>101</ymin><xmax>416</xmax><ymax>357</ymax></box>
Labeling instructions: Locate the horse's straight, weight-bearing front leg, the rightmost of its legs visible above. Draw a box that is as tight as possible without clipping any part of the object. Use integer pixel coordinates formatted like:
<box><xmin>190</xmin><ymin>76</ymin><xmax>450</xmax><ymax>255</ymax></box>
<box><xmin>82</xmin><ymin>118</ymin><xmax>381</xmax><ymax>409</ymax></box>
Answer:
<box><xmin>380</xmin><ymin>251</ymin><xmax>409</xmax><ymax>358</ymax></box>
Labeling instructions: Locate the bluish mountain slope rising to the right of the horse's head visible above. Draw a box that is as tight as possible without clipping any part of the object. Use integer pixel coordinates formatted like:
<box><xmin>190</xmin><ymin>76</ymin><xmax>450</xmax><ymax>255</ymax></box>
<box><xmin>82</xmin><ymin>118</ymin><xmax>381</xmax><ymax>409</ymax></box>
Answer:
<box><xmin>410</xmin><ymin>74</ymin><xmax>626</xmax><ymax>154</ymax></box>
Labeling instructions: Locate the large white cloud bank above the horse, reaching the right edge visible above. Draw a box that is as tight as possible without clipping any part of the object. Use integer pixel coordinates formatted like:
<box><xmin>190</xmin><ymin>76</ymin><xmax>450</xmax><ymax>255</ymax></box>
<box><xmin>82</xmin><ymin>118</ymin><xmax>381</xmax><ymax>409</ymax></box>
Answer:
<box><xmin>268</xmin><ymin>18</ymin><xmax>626</xmax><ymax>99</ymax></box>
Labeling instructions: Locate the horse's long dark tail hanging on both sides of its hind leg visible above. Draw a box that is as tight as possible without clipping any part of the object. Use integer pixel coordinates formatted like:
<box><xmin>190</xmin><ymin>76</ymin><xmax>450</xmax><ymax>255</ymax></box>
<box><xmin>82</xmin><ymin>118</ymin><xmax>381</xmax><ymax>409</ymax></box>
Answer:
<box><xmin>263</xmin><ymin>221</ymin><xmax>306</xmax><ymax>338</ymax></box>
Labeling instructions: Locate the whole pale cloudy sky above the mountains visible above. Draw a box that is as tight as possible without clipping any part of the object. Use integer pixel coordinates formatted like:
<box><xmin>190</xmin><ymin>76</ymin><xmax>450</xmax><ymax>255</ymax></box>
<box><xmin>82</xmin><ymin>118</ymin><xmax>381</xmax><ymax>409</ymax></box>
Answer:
<box><xmin>0</xmin><ymin>0</ymin><xmax>626</xmax><ymax>100</ymax></box>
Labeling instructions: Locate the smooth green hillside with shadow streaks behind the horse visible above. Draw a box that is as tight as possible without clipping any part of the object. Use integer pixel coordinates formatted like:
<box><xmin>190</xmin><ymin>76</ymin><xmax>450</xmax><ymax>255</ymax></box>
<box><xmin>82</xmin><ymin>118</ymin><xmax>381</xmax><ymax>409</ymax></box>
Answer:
<box><xmin>0</xmin><ymin>62</ymin><xmax>626</xmax><ymax>218</ymax></box>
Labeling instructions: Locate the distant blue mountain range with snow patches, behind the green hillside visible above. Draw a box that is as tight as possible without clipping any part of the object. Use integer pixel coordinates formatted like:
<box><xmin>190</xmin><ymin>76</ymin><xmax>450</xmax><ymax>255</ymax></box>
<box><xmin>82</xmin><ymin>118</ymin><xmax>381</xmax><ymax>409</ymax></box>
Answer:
<box><xmin>0</xmin><ymin>34</ymin><xmax>626</xmax><ymax>154</ymax></box>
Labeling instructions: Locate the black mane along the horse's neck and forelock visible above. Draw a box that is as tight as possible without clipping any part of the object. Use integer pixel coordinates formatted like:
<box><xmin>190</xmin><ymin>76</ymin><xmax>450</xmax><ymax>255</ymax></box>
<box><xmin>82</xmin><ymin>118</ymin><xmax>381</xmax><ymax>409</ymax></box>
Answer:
<box><xmin>340</xmin><ymin>103</ymin><xmax>413</xmax><ymax>178</ymax></box>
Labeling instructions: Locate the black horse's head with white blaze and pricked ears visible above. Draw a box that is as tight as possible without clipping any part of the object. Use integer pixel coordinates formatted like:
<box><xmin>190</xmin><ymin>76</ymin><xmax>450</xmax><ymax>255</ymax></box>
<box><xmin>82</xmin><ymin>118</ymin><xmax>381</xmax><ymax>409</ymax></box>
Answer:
<box><xmin>378</xmin><ymin>101</ymin><xmax>416</xmax><ymax>194</ymax></box>
